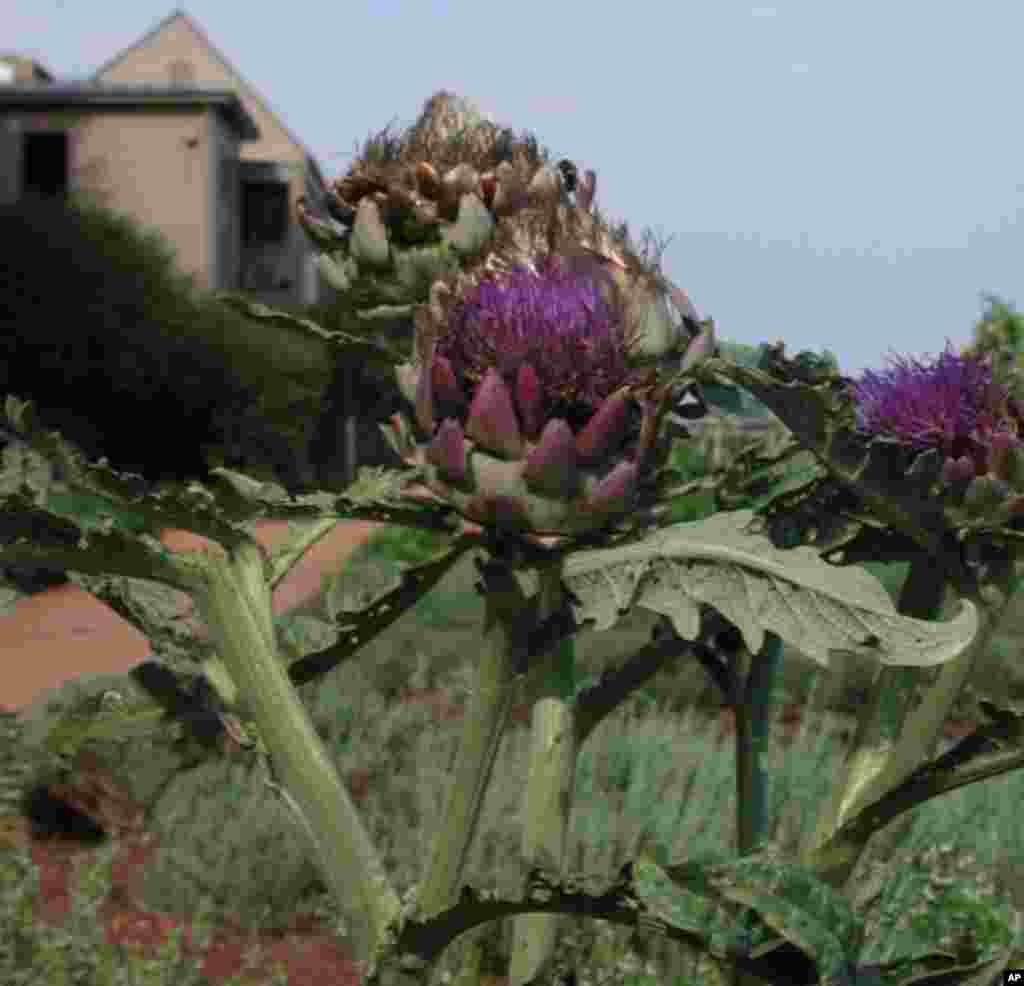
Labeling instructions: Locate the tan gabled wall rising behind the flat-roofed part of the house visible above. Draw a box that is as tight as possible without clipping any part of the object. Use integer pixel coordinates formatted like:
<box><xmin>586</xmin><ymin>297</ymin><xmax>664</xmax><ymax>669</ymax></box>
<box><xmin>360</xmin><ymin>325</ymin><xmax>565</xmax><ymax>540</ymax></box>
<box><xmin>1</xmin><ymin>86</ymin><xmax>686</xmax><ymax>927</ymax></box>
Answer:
<box><xmin>98</xmin><ymin>17</ymin><xmax>318</xmax><ymax>304</ymax></box>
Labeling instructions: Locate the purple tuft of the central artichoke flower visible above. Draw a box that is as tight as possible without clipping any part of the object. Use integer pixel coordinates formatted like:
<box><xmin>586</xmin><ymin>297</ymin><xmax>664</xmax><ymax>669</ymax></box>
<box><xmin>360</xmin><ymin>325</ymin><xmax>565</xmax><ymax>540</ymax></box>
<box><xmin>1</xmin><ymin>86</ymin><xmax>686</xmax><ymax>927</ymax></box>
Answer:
<box><xmin>436</xmin><ymin>260</ymin><xmax>635</xmax><ymax>430</ymax></box>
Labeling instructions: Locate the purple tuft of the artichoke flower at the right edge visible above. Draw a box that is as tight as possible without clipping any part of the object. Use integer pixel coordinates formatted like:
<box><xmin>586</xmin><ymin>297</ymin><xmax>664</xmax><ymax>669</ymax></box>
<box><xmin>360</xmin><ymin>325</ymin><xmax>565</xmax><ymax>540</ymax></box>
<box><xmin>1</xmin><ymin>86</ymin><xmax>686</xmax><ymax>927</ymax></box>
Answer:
<box><xmin>851</xmin><ymin>340</ymin><xmax>1020</xmax><ymax>474</ymax></box>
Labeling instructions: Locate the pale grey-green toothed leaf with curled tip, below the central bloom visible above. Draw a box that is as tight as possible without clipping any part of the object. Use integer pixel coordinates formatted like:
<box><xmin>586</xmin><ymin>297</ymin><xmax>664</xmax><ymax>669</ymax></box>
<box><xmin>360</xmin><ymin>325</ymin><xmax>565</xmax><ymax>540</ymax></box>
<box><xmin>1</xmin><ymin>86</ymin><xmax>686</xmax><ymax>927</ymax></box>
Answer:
<box><xmin>564</xmin><ymin>510</ymin><xmax>978</xmax><ymax>668</ymax></box>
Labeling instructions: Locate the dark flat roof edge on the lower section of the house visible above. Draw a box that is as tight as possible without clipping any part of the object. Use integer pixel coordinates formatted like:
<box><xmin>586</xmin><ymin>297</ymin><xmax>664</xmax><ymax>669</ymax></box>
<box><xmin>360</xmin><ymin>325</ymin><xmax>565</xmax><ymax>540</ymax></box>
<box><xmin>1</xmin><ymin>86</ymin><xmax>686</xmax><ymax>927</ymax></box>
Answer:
<box><xmin>0</xmin><ymin>82</ymin><xmax>259</xmax><ymax>140</ymax></box>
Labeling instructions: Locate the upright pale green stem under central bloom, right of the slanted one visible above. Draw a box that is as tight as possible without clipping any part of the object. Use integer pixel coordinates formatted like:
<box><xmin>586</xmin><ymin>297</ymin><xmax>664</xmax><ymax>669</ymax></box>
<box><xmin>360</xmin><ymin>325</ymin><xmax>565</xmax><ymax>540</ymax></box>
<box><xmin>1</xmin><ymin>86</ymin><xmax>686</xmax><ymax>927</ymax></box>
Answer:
<box><xmin>509</xmin><ymin>562</ymin><xmax>577</xmax><ymax>986</ymax></box>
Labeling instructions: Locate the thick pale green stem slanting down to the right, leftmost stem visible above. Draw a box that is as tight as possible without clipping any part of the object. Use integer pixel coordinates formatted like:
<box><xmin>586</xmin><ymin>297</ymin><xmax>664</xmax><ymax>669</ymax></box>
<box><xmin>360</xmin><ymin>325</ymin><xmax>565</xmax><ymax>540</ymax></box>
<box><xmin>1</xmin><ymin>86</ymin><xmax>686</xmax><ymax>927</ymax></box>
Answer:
<box><xmin>177</xmin><ymin>545</ymin><xmax>399</xmax><ymax>958</ymax></box>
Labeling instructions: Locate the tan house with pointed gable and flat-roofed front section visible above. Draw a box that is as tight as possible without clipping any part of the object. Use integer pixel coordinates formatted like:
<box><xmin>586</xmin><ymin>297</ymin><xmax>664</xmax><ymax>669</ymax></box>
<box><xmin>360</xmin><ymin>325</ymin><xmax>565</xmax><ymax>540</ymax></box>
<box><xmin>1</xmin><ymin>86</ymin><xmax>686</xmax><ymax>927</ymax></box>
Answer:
<box><xmin>0</xmin><ymin>10</ymin><xmax>326</xmax><ymax>305</ymax></box>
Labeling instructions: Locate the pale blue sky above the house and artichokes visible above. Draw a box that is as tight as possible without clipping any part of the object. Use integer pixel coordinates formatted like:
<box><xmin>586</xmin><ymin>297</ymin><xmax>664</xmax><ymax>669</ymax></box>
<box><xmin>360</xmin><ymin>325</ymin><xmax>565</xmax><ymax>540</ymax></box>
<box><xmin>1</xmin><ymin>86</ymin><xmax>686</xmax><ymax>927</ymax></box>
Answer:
<box><xmin>8</xmin><ymin>0</ymin><xmax>1024</xmax><ymax>376</ymax></box>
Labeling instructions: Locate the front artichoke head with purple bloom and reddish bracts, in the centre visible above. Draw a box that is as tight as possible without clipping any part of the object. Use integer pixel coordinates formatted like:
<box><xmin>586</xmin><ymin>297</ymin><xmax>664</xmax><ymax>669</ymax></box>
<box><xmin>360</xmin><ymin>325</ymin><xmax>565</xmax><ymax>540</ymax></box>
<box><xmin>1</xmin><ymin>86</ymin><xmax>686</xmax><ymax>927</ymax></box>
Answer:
<box><xmin>385</xmin><ymin>254</ymin><xmax>707</xmax><ymax>535</ymax></box>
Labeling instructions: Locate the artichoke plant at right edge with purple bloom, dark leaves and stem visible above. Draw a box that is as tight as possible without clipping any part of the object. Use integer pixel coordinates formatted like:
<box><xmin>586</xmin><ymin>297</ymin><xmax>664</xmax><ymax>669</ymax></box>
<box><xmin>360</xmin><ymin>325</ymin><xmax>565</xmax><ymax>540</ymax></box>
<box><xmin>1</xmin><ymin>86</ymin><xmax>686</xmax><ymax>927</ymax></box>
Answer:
<box><xmin>698</xmin><ymin>335</ymin><xmax>1024</xmax><ymax>881</ymax></box>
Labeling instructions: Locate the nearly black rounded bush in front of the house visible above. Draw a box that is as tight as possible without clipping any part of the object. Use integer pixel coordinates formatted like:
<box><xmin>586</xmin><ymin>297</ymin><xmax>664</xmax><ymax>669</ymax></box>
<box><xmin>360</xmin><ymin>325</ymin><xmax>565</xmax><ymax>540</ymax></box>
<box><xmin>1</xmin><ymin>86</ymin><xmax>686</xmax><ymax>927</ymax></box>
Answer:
<box><xmin>0</xmin><ymin>192</ymin><xmax>270</xmax><ymax>480</ymax></box>
